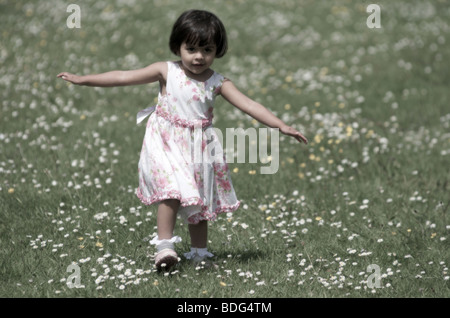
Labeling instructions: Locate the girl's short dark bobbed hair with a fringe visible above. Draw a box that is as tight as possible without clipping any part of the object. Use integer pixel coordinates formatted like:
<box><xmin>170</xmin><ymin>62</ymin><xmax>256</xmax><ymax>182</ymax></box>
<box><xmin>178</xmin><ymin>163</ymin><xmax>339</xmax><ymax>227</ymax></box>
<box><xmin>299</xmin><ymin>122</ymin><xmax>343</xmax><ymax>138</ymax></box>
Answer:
<box><xmin>169</xmin><ymin>10</ymin><xmax>228</xmax><ymax>58</ymax></box>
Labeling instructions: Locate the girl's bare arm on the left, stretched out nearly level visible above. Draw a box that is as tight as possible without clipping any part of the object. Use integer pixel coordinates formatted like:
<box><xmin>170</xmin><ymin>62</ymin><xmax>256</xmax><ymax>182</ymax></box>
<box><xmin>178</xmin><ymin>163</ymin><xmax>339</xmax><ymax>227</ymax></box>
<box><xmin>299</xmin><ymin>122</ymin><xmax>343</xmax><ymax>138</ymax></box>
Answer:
<box><xmin>57</xmin><ymin>62</ymin><xmax>167</xmax><ymax>87</ymax></box>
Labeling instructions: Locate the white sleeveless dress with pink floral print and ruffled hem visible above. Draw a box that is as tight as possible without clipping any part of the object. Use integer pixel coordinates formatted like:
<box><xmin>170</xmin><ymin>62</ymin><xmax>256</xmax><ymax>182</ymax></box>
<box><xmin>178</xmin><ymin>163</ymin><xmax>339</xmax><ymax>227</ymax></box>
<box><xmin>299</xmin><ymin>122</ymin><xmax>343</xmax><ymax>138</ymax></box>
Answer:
<box><xmin>136</xmin><ymin>62</ymin><xmax>240</xmax><ymax>224</ymax></box>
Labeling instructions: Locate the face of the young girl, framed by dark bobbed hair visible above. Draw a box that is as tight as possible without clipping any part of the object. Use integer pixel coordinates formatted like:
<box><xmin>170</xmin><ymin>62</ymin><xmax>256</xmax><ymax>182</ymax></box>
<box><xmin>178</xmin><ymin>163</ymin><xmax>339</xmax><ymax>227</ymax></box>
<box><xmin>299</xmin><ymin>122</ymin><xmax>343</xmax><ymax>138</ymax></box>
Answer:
<box><xmin>180</xmin><ymin>42</ymin><xmax>216</xmax><ymax>76</ymax></box>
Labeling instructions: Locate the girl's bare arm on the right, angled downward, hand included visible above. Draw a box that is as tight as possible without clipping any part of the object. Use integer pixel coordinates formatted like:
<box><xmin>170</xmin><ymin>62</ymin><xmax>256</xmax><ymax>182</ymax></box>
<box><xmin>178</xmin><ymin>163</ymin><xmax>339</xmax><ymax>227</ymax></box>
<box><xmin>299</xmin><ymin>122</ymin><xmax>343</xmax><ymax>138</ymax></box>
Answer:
<box><xmin>221</xmin><ymin>80</ymin><xmax>308</xmax><ymax>144</ymax></box>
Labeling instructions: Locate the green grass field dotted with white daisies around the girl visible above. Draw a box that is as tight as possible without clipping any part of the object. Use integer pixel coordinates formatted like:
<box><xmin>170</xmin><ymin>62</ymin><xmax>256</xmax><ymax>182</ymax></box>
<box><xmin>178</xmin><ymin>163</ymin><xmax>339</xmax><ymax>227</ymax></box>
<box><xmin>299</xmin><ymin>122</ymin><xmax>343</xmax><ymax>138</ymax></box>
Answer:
<box><xmin>0</xmin><ymin>0</ymin><xmax>450</xmax><ymax>298</ymax></box>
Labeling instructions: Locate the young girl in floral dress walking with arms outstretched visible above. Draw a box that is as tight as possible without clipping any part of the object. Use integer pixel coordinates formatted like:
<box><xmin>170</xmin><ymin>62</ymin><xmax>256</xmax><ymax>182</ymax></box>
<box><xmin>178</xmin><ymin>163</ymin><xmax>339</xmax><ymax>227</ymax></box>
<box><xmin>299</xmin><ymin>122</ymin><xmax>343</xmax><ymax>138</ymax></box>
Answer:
<box><xmin>57</xmin><ymin>10</ymin><xmax>308</xmax><ymax>269</ymax></box>
